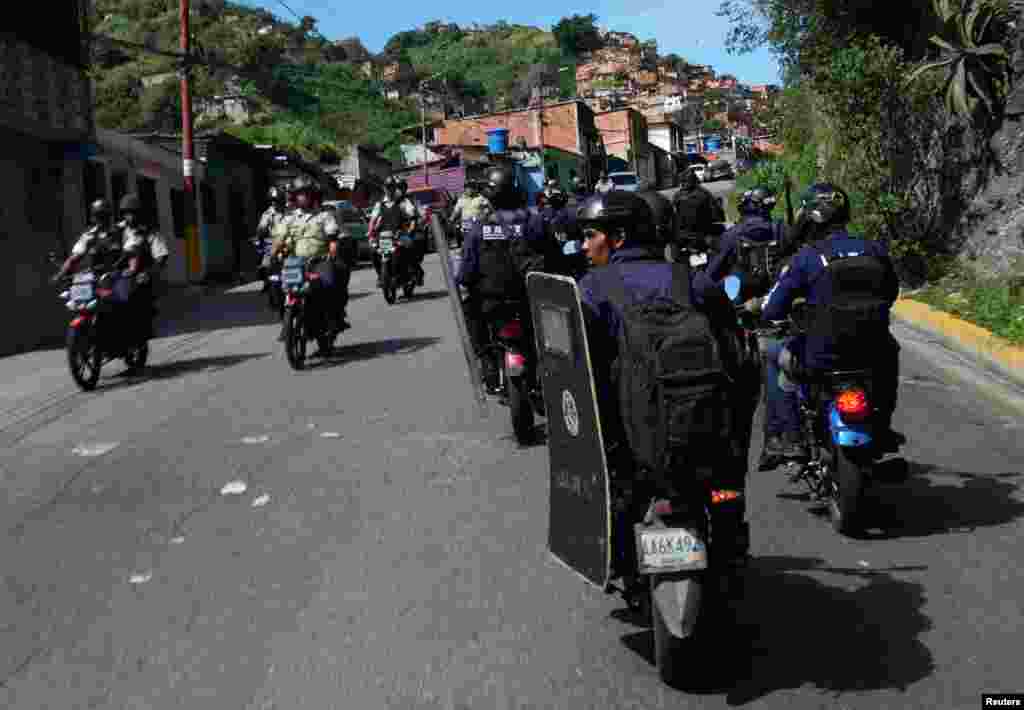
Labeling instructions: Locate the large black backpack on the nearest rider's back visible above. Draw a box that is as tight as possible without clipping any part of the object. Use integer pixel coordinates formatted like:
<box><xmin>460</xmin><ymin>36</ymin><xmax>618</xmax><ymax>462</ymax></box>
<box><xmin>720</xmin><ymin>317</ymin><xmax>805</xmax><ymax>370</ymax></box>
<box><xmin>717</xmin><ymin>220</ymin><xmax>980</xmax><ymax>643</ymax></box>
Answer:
<box><xmin>601</xmin><ymin>264</ymin><xmax>731</xmax><ymax>477</ymax></box>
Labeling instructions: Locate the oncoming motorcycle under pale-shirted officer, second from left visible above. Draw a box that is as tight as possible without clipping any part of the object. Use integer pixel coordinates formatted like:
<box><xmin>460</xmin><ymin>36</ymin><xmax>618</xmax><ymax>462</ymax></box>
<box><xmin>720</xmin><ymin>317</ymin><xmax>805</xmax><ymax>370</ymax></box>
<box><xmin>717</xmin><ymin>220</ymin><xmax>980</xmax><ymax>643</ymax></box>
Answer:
<box><xmin>281</xmin><ymin>256</ymin><xmax>337</xmax><ymax>370</ymax></box>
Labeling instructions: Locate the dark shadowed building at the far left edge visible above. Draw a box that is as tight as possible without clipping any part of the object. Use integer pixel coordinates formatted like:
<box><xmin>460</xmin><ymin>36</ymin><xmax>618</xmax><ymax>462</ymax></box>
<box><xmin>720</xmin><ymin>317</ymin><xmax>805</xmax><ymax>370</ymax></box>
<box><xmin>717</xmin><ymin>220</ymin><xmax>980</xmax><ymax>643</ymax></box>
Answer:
<box><xmin>0</xmin><ymin>0</ymin><xmax>96</xmax><ymax>354</ymax></box>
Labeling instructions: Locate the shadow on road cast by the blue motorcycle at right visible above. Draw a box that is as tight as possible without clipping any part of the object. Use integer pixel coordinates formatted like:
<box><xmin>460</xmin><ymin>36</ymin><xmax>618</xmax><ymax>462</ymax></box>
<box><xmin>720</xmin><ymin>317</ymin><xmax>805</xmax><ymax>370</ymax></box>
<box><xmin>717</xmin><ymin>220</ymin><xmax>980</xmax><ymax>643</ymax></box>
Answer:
<box><xmin>867</xmin><ymin>461</ymin><xmax>1024</xmax><ymax>539</ymax></box>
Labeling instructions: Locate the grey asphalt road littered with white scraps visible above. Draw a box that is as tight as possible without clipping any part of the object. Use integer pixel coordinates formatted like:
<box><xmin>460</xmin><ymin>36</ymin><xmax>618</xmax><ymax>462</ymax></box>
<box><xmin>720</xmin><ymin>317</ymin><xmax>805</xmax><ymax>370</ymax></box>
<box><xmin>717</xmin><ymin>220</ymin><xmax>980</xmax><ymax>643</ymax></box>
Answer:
<box><xmin>0</xmin><ymin>256</ymin><xmax>1024</xmax><ymax>710</ymax></box>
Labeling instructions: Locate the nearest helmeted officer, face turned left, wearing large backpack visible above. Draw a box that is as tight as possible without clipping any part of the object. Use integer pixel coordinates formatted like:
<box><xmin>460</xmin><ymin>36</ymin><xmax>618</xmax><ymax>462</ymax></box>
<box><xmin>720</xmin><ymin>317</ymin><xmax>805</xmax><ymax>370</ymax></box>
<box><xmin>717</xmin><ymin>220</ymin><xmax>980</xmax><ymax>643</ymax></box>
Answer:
<box><xmin>578</xmin><ymin>191</ymin><xmax>750</xmax><ymax>590</ymax></box>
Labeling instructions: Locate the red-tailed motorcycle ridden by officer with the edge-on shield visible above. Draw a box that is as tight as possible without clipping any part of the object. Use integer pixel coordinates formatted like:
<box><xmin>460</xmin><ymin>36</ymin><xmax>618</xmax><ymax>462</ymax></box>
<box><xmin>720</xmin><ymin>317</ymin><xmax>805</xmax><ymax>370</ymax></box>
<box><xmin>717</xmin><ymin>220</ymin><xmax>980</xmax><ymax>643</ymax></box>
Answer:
<box><xmin>483</xmin><ymin>301</ymin><xmax>544</xmax><ymax>444</ymax></box>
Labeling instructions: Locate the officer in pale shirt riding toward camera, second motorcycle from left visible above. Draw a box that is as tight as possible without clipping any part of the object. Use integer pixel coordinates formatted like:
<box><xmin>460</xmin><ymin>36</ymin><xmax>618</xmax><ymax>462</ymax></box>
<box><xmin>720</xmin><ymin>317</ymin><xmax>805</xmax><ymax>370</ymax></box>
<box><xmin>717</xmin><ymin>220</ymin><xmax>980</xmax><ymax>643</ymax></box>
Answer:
<box><xmin>275</xmin><ymin>175</ymin><xmax>351</xmax><ymax>354</ymax></box>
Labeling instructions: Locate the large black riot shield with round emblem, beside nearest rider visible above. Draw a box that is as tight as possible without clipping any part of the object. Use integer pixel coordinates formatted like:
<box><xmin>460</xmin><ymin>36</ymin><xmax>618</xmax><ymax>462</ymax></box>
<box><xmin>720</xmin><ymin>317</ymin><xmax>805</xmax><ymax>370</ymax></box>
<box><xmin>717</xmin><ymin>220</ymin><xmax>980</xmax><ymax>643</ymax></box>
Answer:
<box><xmin>526</xmin><ymin>272</ymin><xmax>611</xmax><ymax>589</ymax></box>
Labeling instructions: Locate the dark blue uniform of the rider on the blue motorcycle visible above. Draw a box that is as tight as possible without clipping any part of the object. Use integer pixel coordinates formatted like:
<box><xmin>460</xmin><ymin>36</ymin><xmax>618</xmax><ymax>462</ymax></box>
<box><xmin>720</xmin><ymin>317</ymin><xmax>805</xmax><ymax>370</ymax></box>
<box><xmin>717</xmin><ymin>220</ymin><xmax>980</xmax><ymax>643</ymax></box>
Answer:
<box><xmin>763</xmin><ymin>229</ymin><xmax>899</xmax><ymax>433</ymax></box>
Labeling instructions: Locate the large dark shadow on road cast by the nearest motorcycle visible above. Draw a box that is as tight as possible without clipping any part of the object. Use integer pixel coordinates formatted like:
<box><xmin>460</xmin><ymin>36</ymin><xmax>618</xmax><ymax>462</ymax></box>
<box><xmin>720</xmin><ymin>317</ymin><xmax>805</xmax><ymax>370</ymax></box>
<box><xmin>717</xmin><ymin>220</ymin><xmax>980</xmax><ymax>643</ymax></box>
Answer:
<box><xmin>623</xmin><ymin>556</ymin><xmax>935</xmax><ymax>707</ymax></box>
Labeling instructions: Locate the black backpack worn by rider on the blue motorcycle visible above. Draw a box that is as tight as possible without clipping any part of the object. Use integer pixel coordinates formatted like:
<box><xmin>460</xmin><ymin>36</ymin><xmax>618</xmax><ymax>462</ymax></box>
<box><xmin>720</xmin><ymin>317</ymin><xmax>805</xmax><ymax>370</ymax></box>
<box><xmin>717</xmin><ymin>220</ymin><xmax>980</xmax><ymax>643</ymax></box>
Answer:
<box><xmin>807</xmin><ymin>240</ymin><xmax>898</xmax><ymax>350</ymax></box>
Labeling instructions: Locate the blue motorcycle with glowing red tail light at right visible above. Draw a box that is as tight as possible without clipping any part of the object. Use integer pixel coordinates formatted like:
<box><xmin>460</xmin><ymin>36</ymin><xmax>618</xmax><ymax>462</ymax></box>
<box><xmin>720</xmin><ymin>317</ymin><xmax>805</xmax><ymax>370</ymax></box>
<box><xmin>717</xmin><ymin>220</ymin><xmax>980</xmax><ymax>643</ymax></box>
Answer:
<box><xmin>723</xmin><ymin>275</ymin><xmax>881</xmax><ymax>537</ymax></box>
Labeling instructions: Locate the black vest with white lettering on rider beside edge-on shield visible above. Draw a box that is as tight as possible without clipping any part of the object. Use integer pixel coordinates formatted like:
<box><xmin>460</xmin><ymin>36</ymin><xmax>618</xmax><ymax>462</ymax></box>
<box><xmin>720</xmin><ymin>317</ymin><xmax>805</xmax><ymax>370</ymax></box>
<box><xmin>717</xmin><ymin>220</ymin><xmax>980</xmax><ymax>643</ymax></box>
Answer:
<box><xmin>479</xmin><ymin>210</ymin><xmax>529</xmax><ymax>300</ymax></box>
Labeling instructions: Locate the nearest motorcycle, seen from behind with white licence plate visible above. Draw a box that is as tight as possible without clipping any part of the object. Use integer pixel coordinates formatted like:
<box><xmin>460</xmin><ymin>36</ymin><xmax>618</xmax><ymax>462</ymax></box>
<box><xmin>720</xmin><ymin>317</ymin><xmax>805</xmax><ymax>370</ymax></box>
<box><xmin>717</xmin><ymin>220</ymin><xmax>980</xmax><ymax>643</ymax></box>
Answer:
<box><xmin>607</xmin><ymin>466</ymin><xmax>746</xmax><ymax>686</ymax></box>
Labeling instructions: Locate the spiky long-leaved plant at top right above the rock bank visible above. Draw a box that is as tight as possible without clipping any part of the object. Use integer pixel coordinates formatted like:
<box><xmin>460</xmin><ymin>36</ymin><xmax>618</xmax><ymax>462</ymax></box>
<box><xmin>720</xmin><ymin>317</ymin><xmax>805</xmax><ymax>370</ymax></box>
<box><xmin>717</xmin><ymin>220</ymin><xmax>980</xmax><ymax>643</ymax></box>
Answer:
<box><xmin>907</xmin><ymin>0</ymin><xmax>1008</xmax><ymax>117</ymax></box>
